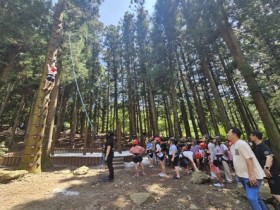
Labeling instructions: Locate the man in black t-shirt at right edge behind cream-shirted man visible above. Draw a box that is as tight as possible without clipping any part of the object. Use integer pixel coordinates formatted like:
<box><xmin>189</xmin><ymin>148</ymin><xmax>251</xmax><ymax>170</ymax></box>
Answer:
<box><xmin>250</xmin><ymin>131</ymin><xmax>280</xmax><ymax>205</ymax></box>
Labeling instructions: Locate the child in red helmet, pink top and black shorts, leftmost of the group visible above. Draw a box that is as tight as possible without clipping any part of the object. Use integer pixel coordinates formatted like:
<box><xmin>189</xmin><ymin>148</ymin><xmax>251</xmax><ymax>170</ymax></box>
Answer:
<box><xmin>129</xmin><ymin>139</ymin><xmax>145</xmax><ymax>177</ymax></box>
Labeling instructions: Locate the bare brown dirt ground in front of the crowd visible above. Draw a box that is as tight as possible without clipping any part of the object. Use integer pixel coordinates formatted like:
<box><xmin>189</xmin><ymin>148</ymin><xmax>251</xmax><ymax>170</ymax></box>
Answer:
<box><xmin>0</xmin><ymin>163</ymin><xmax>273</xmax><ymax>210</ymax></box>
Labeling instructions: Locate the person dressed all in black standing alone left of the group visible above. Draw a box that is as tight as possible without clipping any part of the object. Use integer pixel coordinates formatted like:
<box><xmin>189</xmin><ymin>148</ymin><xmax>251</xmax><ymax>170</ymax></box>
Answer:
<box><xmin>103</xmin><ymin>131</ymin><xmax>114</xmax><ymax>182</ymax></box>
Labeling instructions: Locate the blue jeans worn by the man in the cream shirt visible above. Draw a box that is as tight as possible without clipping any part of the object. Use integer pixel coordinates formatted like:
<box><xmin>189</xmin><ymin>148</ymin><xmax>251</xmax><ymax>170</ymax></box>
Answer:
<box><xmin>238</xmin><ymin>177</ymin><xmax>268</xmax><ymax>210</ymax></box>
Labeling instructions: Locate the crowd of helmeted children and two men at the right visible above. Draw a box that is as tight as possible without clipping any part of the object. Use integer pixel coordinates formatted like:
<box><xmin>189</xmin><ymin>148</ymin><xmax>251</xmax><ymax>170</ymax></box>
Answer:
<box><xmin>127</xmin><ymin>128</ymin><xmax>280</xmax><ymax>210</ymax></box>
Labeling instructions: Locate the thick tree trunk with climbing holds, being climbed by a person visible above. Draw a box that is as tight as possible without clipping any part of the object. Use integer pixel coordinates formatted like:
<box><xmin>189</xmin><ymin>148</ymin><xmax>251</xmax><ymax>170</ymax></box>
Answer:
<box><xmin>18</xmin><ymin>0</ymin><xmax>64</xmax><ymax>173</ymax></box>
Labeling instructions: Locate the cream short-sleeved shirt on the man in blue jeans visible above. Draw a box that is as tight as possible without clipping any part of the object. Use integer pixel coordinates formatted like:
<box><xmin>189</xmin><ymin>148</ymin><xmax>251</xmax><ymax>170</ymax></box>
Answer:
<box><xmin>230</xmin><ymin>139</ymin><xmax>265</xmax><ymax>179</ymax></box>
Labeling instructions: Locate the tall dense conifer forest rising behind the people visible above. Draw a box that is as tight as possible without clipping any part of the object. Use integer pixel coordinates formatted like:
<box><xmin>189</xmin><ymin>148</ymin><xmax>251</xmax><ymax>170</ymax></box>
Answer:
<box><xmin>0</xmin><ymin>0</ymin><xmax>280</xmax><ymax>171</ymax></box>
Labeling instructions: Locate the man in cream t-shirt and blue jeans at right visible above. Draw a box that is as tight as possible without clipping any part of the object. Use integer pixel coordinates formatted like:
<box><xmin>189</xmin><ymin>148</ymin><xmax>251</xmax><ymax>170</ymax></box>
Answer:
<box><xmin>227</xmin><ymin>128</ymin><xmax>267</xmax><ymax>210</ymax></box>
